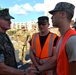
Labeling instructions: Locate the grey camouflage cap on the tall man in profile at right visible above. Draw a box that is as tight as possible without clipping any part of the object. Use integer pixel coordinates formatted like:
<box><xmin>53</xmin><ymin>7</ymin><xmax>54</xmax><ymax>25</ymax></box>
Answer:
<box><xmin>49</xmin><ymin>2</ymin><xmax>75</xmax><ymax>15</ymax></box>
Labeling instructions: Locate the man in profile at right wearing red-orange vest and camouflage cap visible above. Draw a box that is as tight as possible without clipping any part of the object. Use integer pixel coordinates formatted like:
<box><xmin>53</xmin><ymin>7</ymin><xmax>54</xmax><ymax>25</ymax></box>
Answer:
<box><xmin>32</xmin><ymin>2</ymin><xmax>76</xmax><ymax>75</ymax></box>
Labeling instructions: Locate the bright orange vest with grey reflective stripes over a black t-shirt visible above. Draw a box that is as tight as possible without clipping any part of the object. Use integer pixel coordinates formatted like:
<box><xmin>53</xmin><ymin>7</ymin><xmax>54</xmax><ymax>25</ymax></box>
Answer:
<box><xmin>32</xmin><ymin>32</ymin><xmax>57</xmax><ymax>75</ymax></box>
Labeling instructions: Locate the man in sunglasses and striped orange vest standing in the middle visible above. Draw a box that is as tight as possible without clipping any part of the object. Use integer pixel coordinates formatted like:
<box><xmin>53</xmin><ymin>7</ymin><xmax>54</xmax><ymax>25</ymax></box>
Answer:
<box><xmin>26</xmin><ymin>16</ymin><xmax>59</xmax><ymax>75</ymax></box>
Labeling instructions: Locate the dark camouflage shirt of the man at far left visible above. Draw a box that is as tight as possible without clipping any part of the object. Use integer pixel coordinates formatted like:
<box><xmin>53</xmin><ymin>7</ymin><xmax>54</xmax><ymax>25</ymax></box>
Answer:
<box><xmin>0</xmin><ymin>32</ymin><xmax>17</xmax><ymax>68</ymax></box>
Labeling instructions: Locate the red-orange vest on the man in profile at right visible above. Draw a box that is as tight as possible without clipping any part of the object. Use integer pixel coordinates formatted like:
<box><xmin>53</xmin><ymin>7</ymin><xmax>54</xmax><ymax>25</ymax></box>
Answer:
<box><xmin>57</xmin><ymin>29</ymin><xmax>76</xmax><ymax>75</ymax></box>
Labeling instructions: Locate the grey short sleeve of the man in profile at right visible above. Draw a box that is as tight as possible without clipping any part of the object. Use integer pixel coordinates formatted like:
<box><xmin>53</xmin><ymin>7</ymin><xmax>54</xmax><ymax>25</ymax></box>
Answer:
<box><xmin>66</xmin><ymin>35</ymin><xmax>76</xmax><ymax>62</ymax></box>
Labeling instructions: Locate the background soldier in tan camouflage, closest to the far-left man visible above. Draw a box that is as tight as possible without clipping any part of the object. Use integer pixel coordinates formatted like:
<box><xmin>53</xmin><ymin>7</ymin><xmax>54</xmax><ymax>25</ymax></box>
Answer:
<box><xmin>14</xmin><ymin>26</ymin><xmax>29</xmax><ymax>62</ymax></box>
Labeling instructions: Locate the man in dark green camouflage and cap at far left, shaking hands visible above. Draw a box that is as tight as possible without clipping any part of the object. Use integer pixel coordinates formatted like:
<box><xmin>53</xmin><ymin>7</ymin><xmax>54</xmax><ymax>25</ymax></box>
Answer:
<box><xmin>0</xmin><ymin>8</ymin><xmax>30</xmax><ymax>75</ymax></box>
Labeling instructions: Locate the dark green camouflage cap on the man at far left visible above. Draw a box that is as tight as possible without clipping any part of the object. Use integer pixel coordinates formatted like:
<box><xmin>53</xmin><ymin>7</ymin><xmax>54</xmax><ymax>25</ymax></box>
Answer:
<box><xmin>0</xmin><ymin>8</ymin><xmax>14</xmax><ymax>19</ymax></box>
